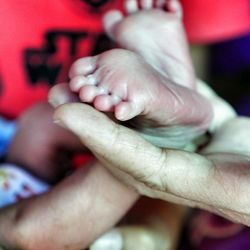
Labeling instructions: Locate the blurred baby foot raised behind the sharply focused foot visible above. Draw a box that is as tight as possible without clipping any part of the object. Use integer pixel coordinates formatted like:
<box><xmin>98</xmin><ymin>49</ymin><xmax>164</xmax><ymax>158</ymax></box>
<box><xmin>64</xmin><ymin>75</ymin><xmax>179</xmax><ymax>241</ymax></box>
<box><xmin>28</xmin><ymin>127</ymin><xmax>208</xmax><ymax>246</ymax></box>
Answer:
<box><xmin>103</xmin><ymin>0</ymin><xmax>195</xmax><ymax>88</ymax></box>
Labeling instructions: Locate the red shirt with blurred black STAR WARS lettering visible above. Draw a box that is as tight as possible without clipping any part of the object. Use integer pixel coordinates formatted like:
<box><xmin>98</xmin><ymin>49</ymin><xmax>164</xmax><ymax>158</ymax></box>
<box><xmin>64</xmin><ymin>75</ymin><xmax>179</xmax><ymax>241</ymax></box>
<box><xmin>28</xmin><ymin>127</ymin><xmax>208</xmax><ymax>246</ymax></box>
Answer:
<box><xmin>0</xmin><ymin>0</ymin><xmax>122</xmax><ymax>117</ymax></box>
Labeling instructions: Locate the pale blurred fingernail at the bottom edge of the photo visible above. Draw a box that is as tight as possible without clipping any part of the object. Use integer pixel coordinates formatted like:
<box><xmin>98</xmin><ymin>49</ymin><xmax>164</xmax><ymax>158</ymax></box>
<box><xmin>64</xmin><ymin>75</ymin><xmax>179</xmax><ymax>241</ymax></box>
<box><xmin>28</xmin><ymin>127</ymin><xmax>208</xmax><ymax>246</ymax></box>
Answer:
<box><xmin>90</xmin><ymin>229</ymin><xmax>123</xmax><ymax>250</ymax></box>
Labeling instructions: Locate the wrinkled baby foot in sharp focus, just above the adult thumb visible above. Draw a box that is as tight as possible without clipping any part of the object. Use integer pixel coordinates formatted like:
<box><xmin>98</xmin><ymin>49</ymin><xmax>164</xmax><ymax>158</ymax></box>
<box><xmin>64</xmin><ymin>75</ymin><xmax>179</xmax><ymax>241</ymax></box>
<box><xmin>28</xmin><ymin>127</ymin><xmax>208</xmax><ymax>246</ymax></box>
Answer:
<box><xmin>70</xmin><ymin>49</ymin><xmax>211</xmax><ymax>148</ymax></box>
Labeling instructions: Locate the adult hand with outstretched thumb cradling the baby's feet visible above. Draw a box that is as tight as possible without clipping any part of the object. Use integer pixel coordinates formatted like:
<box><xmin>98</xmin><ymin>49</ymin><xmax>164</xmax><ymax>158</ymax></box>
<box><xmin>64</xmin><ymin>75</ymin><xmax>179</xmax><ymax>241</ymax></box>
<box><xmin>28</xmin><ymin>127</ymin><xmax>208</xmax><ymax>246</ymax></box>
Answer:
<box><xmin>54</xmin><ymin>103</ymin><xmax>250</xmax><ymax>225</ymax></box>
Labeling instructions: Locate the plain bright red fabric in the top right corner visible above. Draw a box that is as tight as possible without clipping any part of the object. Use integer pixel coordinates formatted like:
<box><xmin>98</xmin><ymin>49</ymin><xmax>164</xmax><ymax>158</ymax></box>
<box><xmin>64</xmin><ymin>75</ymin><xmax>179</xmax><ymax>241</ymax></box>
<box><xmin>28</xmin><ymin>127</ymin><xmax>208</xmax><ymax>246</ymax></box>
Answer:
<box><xmin>181</xmin><ymin>0</ymin><xmax>250</xmax><ymax>44</ymax></box>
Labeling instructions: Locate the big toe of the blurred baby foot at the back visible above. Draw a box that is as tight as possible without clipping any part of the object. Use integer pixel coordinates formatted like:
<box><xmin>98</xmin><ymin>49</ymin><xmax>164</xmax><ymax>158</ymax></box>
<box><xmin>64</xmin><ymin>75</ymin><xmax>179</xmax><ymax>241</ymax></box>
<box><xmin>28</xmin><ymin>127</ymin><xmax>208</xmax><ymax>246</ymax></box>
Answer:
<box><xmin>103</xmin><ymin>10</ymin><xmax>124</xmax><ymax>39</ymax></box>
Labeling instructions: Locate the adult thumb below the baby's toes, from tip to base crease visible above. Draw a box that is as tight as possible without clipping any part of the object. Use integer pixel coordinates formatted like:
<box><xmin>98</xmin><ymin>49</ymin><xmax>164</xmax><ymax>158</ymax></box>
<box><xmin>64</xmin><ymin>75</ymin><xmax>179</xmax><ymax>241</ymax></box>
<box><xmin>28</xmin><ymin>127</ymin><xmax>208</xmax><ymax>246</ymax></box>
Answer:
<box><xmin>54</xmin><ymin>103</ymin><xmax>164</xmax><ymax>186</ymax></box>
